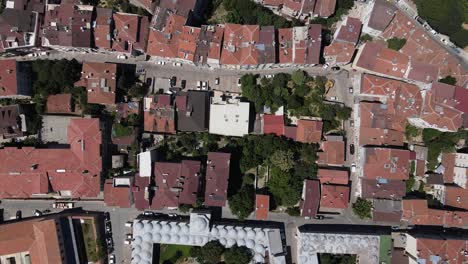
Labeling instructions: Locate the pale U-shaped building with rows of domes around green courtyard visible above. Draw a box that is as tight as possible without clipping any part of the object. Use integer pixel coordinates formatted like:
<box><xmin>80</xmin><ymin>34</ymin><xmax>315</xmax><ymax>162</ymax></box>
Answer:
<box><xmin>132</xmin><ymin>213</ymin><xmax>286</xmax><ymax>264</ymax></box>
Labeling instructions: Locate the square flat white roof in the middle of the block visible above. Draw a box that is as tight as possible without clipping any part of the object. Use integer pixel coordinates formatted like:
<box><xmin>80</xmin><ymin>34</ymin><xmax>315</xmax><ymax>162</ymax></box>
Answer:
<box><xmin>209</xmin><ymin>97</ymin><xmax>250</xmax><ymax>137</ymax></box>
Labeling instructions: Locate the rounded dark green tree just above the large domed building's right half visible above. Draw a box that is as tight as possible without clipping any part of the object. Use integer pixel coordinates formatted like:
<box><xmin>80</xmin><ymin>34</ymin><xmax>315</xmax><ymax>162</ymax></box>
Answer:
<box><xmin>228</xmin><ymin>185</ymin><xmax>255</xmax><ymax>220</ymax></box>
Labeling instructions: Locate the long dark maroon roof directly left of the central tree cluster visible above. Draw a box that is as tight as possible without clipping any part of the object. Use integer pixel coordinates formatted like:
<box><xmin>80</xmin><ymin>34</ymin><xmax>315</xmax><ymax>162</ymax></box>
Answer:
<box><xmin>205</xmin><ymin>152</ymin><xmax>231</xmax><ymax>207</ymax></box>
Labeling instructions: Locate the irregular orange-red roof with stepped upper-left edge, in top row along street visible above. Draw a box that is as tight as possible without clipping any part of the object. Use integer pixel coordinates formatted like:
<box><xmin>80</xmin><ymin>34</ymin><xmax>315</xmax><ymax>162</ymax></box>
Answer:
<box><xmin>146</xmin><ymin>14</ymin><xmax>187</xmax><ymax>58</ymax></box>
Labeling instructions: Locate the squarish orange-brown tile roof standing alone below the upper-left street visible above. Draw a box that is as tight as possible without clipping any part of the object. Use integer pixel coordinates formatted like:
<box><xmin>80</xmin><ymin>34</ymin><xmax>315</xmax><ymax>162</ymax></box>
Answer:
<box><xmin>75</xmin><ymin>62</ymin><xmax>117</xmax><ymax>104</ymax></box>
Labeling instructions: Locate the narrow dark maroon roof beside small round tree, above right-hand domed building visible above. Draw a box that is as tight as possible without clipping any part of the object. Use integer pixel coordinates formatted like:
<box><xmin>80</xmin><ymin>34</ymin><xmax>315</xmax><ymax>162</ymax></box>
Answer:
<box><xmin>299</xmin><ymin>180</ymin><xmax>320</xmax><ymax>218</ymax></box>
